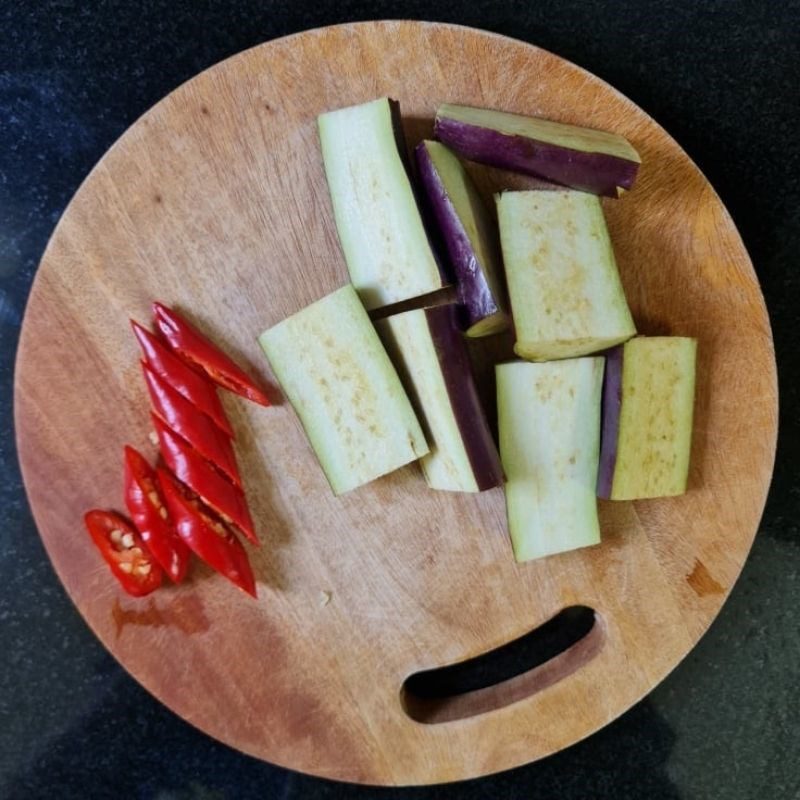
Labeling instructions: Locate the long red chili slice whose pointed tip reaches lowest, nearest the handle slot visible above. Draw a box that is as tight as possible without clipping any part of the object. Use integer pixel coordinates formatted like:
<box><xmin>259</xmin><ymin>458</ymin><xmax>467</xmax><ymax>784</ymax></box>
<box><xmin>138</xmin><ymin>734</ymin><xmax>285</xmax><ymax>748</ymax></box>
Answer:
<box><xmin>157</xmin><ymin>467</ymin><xmax>256</xmax><ymax>597</ymax></box>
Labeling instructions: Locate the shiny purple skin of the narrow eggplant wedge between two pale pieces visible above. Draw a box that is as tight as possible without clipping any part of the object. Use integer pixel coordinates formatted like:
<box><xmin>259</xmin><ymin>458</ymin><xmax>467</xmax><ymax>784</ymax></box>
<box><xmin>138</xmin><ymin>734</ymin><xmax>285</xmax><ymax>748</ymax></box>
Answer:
<box><xmin>414</xmin><ymin>141</ymin><xmax>508</xmax><ymax>335</ymax></box>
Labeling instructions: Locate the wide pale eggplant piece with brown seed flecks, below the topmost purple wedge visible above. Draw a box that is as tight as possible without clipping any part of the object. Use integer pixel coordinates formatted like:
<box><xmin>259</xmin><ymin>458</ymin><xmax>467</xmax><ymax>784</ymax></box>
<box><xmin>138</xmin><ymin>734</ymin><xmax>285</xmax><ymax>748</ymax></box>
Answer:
<box><xmin>497</xmin><ymin>190</ymin><xmax>636</xmax><ymax>361</ymax></box>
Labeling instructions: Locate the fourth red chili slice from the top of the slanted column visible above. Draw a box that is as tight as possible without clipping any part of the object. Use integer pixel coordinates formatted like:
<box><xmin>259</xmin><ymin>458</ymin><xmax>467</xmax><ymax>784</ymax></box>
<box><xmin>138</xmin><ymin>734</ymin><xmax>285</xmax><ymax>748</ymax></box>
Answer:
<box><xmin>152</xmin><ymin>414</ymin><xmax>259</xmax><ymax>545</ymax></box>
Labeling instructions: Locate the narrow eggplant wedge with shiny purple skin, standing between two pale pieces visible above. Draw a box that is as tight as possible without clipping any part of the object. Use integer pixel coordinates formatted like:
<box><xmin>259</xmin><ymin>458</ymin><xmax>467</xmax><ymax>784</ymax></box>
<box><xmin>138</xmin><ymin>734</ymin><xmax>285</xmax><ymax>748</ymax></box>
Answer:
<box><xmin>415</xmin><ymin>141</ymin><xmax>509</xmax><ymax>337</ymax></box>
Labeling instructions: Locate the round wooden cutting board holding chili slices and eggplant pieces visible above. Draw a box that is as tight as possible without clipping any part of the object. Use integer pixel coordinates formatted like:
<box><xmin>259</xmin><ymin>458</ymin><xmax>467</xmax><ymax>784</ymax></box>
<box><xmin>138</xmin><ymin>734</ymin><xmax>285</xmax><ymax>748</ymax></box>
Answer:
<box><xmin>16</xmin><ymin>22</ymin><xmax>777</xmax><ymax>784</ymax></box>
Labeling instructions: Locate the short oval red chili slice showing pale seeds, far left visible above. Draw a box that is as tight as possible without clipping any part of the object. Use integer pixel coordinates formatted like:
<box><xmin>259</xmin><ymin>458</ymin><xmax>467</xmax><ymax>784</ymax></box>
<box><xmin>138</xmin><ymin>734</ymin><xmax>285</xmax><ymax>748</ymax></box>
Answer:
<box><xmin>83</xmin><ymin>509</ymin><xmax>162</xmax><ymax>597</ymax></box>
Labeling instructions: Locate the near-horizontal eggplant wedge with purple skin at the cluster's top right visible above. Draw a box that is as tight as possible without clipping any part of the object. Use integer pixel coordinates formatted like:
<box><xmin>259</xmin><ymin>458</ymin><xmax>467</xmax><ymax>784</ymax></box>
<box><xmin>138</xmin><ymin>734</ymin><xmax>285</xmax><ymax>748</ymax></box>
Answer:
<box><xmin>434</xmin><ymin>105</ymin><xmax>641</xmax><ymax>197</ymax></box>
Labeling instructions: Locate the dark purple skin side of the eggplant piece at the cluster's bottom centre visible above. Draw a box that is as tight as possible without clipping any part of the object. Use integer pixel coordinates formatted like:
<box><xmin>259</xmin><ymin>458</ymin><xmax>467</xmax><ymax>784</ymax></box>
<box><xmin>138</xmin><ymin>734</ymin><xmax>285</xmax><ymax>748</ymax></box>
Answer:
<box><xmin>425</xmin><ymin>305</ymin><xmax>505</xmax><ymax>492</ymax></box>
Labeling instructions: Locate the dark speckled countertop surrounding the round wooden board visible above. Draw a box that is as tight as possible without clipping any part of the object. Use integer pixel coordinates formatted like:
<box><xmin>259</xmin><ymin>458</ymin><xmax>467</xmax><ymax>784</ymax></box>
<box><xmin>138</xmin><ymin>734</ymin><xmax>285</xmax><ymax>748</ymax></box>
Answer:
<box><xmin>0</xmin><ymin>0</ymin><xmax>800</xmax><ymax>800</ymax></box>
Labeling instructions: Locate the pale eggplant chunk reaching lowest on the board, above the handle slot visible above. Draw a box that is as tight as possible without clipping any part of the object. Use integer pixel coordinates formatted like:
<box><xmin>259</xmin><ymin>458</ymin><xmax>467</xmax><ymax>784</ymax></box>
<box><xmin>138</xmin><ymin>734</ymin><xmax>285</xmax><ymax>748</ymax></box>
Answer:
<box><xmin>496</xmin><ymin>357</ymin><xmax>603</xmax><ymax>561</ymax></box>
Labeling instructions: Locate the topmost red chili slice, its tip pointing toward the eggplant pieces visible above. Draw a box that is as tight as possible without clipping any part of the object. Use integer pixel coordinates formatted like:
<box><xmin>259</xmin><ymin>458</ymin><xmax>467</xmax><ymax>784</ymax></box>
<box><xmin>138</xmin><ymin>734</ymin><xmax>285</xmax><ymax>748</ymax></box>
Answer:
<box><xmin>153</xmin><ymin>303</ymin><xmax>270</xmax><ymax>406</ymax></box>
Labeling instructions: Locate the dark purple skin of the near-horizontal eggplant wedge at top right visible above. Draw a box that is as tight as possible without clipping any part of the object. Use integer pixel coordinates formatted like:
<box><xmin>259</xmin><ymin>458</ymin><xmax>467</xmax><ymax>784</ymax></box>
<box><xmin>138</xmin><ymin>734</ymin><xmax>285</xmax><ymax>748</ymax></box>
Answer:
<box><xmin>434</xmin><ymin>114</ymin><xmax>639</xmax><ymax>197</ymax></box>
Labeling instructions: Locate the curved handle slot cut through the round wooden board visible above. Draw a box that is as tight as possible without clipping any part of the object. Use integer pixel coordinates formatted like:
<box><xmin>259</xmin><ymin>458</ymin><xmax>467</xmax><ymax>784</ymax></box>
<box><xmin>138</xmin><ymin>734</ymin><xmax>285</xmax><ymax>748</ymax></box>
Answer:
<box><xmin>400</xmin><ymin>606</ymin><xmax>605</xmax><ymax>724</ymax></box>
